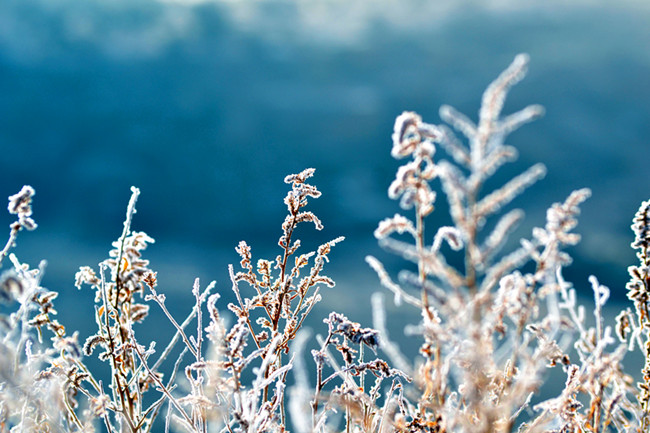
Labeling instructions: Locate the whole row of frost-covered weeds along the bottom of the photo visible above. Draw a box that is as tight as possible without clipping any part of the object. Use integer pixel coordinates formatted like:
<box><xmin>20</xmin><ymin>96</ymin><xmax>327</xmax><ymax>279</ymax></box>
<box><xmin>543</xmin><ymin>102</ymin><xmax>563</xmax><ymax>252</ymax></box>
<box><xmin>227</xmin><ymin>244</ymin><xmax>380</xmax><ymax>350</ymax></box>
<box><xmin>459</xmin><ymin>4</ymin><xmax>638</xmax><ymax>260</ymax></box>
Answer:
<box><xmin>0</xmin><ymin>55</ymin><xmax>650</xmax><ymax>433</ymax></box>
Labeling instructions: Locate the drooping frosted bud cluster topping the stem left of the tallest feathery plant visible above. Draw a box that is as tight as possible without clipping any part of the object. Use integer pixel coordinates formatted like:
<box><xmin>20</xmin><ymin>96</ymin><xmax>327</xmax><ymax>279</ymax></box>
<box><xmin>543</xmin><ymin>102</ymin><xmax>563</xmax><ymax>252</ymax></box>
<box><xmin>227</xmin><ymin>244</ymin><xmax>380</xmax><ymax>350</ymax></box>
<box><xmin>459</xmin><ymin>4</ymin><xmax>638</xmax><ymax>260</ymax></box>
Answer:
<box><xmin>388</xmin><ymin>111</ymin><xmax>442</xmax><ymax>215</ymax></box>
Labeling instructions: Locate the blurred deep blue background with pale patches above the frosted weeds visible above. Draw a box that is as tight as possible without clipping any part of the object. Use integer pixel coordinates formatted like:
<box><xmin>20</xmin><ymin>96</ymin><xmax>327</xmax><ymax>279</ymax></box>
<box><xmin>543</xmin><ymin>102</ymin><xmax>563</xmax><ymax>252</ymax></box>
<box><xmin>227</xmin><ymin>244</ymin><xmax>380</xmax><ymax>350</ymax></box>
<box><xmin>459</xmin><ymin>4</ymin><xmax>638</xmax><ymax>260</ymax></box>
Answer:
<box><xmin>0</xmin><ymin>0</ymin><xmax>650</xmax><ymax>340</ymax></box>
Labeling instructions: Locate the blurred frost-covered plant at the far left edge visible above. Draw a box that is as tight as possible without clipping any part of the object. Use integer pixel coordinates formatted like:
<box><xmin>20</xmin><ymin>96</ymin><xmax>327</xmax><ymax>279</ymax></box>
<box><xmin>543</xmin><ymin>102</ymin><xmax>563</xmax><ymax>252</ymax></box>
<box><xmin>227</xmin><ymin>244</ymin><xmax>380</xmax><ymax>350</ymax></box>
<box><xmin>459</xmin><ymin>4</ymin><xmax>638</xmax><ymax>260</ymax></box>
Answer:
<box><xmin>0</xmin><ymin>186</ymin><xmax>94</xmax><ymax>432</ymax></box>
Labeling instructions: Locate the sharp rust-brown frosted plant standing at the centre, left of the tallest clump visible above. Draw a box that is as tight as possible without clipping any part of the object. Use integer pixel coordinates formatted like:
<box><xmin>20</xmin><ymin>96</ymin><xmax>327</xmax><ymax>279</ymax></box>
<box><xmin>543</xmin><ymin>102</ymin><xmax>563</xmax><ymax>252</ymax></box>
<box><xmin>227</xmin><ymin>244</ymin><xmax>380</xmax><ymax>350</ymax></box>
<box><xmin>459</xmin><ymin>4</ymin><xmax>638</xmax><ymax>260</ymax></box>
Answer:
<box><xmin>208</xmin><ymin>168</ymin><xmax>343</xmax><ymax>433</ymax></box>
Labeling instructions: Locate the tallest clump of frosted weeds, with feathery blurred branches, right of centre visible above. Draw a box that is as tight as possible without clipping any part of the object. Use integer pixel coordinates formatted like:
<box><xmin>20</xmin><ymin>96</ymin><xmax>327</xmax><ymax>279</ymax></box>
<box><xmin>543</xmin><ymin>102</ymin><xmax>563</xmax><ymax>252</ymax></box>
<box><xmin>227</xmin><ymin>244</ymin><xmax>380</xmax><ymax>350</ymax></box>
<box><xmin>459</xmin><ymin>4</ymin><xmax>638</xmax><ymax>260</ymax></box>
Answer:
<box><xmin>360</xmin><ymin>55</ymin><xmax>635</xmax><ymax>432</ymax></box>
